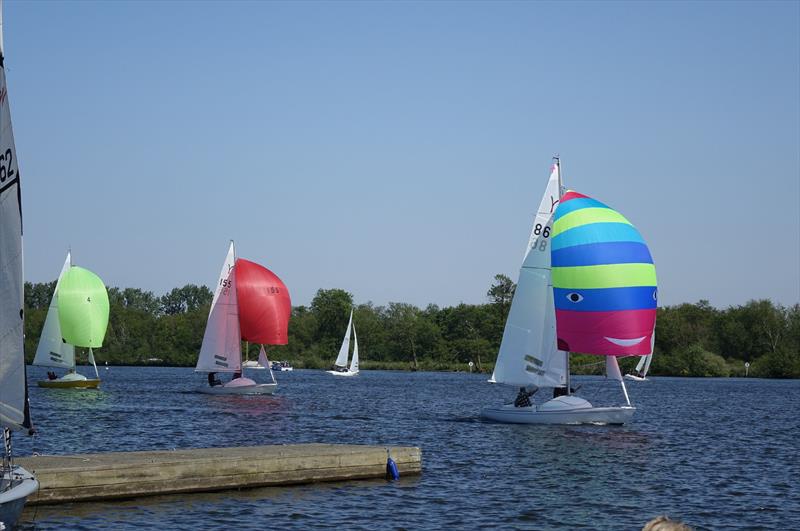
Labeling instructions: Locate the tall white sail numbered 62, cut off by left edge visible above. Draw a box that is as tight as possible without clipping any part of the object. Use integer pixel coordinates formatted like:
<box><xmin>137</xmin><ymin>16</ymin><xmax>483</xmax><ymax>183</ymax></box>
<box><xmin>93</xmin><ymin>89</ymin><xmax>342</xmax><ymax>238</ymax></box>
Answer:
<box><xmin>0</xmin><ymin>42</ymin><xmax>26</xmax><ymax>429</ymax></box>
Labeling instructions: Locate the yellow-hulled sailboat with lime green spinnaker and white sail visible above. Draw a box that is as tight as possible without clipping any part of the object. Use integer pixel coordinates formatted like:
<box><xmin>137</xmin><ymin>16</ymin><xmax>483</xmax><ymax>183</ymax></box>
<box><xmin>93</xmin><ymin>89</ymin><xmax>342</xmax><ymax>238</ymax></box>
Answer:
<box><xmin>33</xmin><ymin>252</ymin><xmax>109</xmax><ymax>389</ymax></box>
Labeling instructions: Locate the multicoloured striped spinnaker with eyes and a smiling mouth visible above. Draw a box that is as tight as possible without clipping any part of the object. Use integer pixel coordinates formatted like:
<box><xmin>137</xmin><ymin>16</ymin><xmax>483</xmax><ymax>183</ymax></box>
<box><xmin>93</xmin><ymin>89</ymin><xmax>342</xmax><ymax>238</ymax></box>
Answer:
<box><xmin>551</xmin><ymin>191</ymin><xmax>657</xmax><ymax>356</ymax></box>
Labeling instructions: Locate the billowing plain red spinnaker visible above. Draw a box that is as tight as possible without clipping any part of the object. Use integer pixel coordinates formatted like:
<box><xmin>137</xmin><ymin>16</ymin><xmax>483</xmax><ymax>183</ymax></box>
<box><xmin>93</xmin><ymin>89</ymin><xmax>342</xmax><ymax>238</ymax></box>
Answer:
<box><xmin>235</xmin><ymin>258</ymin><xmax>292</xmax><ymax>345</ymax></box>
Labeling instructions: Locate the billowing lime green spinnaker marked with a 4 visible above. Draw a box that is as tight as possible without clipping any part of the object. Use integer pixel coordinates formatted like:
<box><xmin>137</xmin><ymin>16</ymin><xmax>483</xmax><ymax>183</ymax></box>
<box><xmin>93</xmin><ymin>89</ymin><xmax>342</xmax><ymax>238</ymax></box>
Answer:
<box><xmin>58</xmin><ymin>266</ymin><xmax>108</xmax><ymax>348</ymax></box>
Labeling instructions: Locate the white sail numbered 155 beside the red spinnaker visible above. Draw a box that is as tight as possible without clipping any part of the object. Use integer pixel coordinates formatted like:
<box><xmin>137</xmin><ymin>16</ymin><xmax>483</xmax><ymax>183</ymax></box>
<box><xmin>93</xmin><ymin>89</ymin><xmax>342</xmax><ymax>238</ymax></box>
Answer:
<box><xmin>194</xmin><ymin>242</ymin><xmax>242</xmax><ymax>372</ymax></box>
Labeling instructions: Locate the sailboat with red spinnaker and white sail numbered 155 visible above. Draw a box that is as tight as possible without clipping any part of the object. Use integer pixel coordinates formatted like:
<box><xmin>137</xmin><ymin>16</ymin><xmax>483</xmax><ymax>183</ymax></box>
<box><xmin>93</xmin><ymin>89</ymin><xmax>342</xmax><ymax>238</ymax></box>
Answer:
<box><xmin>195</xmin><ymin>241</ymin><xmax>292</xmax><ymax>395</ymax></box>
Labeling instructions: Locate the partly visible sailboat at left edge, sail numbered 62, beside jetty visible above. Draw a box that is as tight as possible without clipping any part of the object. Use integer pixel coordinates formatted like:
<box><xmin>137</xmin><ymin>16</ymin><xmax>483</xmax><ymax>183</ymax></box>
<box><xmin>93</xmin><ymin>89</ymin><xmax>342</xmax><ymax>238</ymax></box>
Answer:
<box><xmin>0</xmin><ymin>3</ymin><xmax>39</xmax><ymax>527</ymax></box>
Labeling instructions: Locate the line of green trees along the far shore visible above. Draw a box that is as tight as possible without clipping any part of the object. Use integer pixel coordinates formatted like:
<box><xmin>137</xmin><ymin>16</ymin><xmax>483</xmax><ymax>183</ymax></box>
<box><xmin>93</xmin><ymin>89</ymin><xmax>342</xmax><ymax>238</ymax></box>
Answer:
<box><xmin>25</xmin><ymin>275</ymin><xmax>800</xmax><ymax>378</ymax></box>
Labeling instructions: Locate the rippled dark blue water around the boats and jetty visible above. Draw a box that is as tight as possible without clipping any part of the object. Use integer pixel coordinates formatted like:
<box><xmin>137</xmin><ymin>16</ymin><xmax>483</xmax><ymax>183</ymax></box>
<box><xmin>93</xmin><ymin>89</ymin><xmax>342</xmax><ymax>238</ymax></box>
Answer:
<box><xmin>14</xmin><ymin>367</ymin><xmax>800</xmax><ymax>530</ymax></box>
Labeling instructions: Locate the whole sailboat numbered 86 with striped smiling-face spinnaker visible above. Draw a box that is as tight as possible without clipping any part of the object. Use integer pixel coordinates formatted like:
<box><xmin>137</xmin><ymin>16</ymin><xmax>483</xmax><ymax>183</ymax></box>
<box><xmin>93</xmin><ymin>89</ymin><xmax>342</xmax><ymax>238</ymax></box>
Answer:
<box><xmin>481</xmin><ymin>157</ymin><xmax>657</xmax><ymax>424</ymax></box>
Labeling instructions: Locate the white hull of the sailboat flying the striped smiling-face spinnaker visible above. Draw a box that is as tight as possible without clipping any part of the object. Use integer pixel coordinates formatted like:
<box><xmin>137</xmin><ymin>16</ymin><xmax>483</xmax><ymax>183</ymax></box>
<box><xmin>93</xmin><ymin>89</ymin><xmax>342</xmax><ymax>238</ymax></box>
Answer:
<box><xmin>481</xmin><ymin>396</ymin><xmax>636</xmax><ymax>424</ymax></box>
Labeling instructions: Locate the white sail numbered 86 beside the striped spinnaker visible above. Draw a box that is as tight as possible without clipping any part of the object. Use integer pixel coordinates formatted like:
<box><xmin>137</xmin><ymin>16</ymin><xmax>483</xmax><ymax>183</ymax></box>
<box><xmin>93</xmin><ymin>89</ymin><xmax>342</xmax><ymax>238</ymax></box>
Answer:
<box><xmin>489</xmin><ymin>165</ymin><xmax>567</xmax><ymax>387</ymax></box>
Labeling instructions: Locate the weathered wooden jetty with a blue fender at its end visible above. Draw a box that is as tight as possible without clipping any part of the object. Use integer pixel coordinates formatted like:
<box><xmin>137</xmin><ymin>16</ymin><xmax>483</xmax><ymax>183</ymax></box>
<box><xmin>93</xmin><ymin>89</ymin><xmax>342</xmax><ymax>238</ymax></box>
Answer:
<box><xmin>15</xmin><ymin>444</ymin><xmax>422</xmax><ymax>504</ymax></box>
